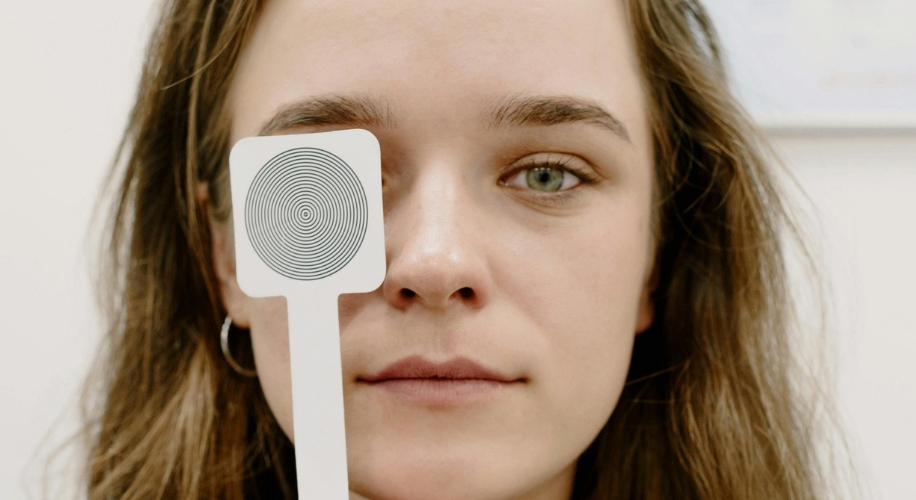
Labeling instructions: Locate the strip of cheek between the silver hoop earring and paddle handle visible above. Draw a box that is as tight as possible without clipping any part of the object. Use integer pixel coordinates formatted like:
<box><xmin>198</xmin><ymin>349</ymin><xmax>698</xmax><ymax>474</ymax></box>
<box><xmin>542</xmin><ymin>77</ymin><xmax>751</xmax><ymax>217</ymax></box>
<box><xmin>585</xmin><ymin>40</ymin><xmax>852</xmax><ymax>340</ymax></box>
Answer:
<box><xmin>248</xmin><ymin>297</ymin><xmax>293</xmax><ymax>438</ymax></box>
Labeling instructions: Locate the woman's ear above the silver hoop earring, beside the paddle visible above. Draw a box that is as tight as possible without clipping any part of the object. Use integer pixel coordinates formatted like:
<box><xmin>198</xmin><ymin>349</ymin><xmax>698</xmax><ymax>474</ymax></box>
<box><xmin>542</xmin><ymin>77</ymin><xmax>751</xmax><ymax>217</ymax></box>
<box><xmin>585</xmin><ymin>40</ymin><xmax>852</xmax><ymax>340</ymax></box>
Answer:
<box><xmin>197</xmin><ymin>182</ymin><xmax>250</xmax><ymax>328</ymax></box>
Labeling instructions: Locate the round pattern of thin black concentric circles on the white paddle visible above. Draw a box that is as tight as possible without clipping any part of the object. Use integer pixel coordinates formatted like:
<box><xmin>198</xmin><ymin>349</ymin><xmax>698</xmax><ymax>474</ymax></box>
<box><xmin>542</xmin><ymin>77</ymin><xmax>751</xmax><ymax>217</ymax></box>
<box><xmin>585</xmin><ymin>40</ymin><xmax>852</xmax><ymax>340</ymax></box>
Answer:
<box><xmin>245</xmin><ymin>148</ymin><xmax>369</xmax><ymax>281</ymax></box>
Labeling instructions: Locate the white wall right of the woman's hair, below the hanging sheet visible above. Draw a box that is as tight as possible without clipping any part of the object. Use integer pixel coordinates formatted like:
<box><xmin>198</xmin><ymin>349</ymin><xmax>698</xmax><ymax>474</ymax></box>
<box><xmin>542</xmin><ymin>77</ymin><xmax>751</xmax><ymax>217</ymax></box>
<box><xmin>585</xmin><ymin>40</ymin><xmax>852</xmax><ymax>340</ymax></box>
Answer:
<box><xmin>774</xmin><ymin>133</ymin><xmax>916</xmax><ymax>500</ymax></box>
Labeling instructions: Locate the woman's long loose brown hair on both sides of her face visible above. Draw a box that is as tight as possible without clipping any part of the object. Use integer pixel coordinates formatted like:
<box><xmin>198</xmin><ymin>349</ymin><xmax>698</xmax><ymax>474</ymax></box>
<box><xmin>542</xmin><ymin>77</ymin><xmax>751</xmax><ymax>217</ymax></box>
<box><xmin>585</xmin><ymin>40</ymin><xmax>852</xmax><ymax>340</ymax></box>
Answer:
<box><xmin>87</xmin><ymin>0</ymin><xmax>852</xmax><ymax>500</ymax></box>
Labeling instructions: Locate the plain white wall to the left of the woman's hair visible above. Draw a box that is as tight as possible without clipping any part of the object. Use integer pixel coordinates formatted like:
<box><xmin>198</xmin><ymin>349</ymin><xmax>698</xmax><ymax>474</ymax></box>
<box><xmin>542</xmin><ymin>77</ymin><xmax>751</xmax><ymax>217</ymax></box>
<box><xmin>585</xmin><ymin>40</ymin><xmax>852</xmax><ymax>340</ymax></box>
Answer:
<box><xmin>0</xmin><ymin>0</ymin><xmax>152</xmax><ymax>499</ymax></box>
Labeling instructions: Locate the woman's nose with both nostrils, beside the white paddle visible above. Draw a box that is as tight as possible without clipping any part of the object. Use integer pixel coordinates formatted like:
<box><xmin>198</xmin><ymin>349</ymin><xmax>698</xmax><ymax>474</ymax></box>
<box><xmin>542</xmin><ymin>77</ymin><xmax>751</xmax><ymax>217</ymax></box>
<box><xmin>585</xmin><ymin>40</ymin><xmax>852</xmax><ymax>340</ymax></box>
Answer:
<box><xmin>382</xmin><ymin>166</ymin><xmax>492</xmax><ymax>310</ymax></box>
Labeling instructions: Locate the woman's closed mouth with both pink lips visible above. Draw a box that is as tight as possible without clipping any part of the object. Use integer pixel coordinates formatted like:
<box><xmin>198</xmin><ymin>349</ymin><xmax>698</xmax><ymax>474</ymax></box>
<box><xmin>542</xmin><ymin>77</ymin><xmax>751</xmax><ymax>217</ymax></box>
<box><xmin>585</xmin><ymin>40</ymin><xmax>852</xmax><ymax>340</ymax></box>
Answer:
<box><xmin>357</xmin><ymin>356</ymin><xmax>526</xmax><ymax>407</ymax></box>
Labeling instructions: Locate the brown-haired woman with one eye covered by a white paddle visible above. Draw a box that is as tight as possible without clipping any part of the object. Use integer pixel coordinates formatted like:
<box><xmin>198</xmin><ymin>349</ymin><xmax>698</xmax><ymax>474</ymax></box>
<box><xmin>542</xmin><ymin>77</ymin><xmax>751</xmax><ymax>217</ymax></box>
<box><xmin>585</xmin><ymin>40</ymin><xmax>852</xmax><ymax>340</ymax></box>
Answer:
<box><xmin>89</xmin><ymin>0</ymin><xmax>844</xmax><ymax>499</ymax></box>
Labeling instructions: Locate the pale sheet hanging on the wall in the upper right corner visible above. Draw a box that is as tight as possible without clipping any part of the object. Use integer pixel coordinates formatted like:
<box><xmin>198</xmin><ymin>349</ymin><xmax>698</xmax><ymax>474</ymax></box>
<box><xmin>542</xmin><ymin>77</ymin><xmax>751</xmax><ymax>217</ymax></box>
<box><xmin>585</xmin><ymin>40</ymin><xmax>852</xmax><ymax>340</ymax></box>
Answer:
<box><xmin>704</xmin><ymin>0</ymin><xmax>916</xmax><ymax>129</ymax></box>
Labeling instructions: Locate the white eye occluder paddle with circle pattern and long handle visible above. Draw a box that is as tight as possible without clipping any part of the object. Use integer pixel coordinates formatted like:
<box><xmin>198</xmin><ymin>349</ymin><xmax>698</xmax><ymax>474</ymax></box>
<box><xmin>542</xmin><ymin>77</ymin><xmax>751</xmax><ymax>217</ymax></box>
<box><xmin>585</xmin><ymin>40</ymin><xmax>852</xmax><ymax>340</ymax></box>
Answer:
<box><xmin>229</xmin><ymin>129</ymin><xmax>386</xmax><ymax>500</ymax></box>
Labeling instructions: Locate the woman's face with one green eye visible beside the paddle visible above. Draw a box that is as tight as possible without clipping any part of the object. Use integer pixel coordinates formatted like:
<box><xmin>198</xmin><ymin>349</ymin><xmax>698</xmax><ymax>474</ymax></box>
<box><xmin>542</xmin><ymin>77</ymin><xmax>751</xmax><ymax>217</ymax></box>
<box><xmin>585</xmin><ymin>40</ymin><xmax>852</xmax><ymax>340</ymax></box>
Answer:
<box><xmin>215</xmin><ymin>0</ymin><xmax>654</xmax><ymax>499</ymax></box>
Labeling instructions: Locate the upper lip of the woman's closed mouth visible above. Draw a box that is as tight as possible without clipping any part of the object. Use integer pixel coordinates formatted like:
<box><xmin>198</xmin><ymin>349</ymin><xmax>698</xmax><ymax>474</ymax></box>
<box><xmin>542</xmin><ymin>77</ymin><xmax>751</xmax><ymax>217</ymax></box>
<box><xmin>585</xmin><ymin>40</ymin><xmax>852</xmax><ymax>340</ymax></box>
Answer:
<box><xmin>359</xmin><ymin>356</ymin><xmax>521</xmax><ymax>383</ymax></box>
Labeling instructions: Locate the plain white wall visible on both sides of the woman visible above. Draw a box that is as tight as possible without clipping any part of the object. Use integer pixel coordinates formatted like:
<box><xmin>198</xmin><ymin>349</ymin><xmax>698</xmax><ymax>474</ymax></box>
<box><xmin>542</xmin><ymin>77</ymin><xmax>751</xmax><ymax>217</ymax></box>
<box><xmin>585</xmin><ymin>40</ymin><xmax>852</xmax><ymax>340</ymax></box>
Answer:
<box><xmin>0</xmin><ymin>0</ymin><xmax>916</xmax><ymax>500</ymax></box>
